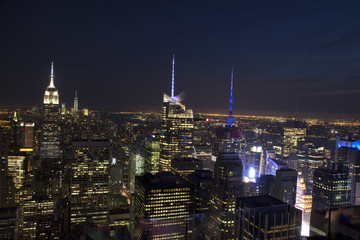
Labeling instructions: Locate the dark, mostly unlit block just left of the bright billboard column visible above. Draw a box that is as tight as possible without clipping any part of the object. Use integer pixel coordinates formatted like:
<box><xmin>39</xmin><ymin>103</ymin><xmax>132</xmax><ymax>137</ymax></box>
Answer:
<box><xmin>271</xmin><ymin>168</ymin><xmax>298</xmax><ymax>206</ymax></box>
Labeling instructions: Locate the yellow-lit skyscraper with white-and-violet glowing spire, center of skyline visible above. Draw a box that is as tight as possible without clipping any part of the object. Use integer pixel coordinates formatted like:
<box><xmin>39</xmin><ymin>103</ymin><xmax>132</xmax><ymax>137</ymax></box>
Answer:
<box><xmin>160</xmin><ymin>56</ymin><xmax>194</xmax><ymax>171</ymax></box>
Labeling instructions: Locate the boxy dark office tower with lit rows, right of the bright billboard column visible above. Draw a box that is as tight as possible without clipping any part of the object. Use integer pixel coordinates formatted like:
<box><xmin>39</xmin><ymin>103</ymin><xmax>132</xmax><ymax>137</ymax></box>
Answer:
<box><xmin>312</xmin><ymin>164</ymin><xmax>351</xmax><ymax>210</ymax></box>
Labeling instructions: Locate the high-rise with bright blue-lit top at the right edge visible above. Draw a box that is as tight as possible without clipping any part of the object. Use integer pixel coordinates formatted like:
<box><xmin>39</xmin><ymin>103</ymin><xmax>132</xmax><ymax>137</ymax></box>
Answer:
<box><xmin>335</xmin><ymin>137</ymin><xmax>360</xmax><ymax>205</ymax></box>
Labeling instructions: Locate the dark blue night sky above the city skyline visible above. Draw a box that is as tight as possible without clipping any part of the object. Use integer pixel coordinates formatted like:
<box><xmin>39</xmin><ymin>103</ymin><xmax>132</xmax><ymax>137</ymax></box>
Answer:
<box><xmin>0</xmin><ymin>0</ymin><xmax>360</xmax><ymax>116</ymax></box>
